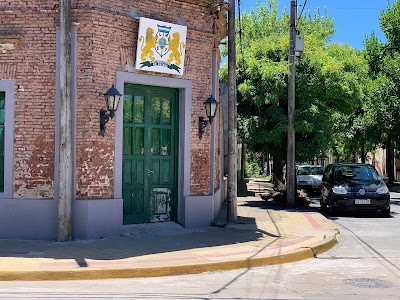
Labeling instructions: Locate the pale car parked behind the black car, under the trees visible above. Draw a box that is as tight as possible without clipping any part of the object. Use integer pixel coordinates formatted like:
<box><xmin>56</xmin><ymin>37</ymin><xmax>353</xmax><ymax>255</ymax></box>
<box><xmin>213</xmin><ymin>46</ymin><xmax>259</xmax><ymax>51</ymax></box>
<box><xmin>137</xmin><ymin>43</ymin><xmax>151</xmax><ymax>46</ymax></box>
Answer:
<box><xmin>296</xmin><ymin>165</ymin><xmax>324</xmax><ymax>192</ymax></box>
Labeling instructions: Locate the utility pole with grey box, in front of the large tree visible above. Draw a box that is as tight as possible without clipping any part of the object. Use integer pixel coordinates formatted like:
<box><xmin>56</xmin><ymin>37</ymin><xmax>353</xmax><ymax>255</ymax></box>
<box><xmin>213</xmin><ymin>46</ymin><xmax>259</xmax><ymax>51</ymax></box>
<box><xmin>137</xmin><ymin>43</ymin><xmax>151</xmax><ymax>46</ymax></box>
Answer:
<box><xmin>286</xmin><ymin>0</ymin><xmax>297</xmax><ymax>208</ymax></box>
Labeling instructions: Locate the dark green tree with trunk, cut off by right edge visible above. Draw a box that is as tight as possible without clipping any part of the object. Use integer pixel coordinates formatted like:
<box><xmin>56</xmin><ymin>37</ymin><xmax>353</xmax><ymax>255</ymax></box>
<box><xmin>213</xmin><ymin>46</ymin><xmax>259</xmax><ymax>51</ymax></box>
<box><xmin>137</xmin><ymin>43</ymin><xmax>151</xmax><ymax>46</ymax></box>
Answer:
<box><xmin>363</xmin><ymin>0</ymin><xmax>400</xmax><ymax>182</ymax></box>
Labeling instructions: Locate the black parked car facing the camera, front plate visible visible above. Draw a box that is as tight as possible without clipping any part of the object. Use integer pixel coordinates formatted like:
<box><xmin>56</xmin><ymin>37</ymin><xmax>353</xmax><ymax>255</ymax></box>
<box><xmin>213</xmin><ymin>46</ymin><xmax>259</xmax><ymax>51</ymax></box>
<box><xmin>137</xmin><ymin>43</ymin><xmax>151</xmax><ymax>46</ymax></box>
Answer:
<box><xmin>321</xmin><ymin>163</ymin><xmax>390</xmax><ymax>216</ymax></box>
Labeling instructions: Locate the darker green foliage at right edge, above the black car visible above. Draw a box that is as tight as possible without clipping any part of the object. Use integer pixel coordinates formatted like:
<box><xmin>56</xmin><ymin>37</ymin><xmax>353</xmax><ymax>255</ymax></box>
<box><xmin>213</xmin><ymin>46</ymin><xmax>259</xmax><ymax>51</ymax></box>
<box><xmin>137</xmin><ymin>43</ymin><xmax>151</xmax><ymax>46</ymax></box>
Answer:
<box><xmin>333</xmin><ymin>0</ymin><xmax>400</xmax><ymax>164</ymax></box>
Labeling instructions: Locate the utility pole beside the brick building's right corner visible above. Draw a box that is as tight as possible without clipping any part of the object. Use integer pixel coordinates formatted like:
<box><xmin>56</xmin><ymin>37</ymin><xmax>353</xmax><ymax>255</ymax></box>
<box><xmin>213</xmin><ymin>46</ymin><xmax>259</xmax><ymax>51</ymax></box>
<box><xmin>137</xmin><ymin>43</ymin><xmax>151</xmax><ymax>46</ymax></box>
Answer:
<box><xmin>227</xmin><ymin>0</ymin><xmax>237</xmax><ymax>222</ymax></box>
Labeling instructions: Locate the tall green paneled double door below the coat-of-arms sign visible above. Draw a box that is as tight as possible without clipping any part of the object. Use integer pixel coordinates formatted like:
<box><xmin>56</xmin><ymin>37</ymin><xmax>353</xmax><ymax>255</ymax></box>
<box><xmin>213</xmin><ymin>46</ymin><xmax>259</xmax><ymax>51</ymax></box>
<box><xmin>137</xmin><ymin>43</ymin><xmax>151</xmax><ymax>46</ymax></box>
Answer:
<box><xmin>122</xmin><ymin>84</ymin><xmax>178</xmax><ymax>224</ymax></box>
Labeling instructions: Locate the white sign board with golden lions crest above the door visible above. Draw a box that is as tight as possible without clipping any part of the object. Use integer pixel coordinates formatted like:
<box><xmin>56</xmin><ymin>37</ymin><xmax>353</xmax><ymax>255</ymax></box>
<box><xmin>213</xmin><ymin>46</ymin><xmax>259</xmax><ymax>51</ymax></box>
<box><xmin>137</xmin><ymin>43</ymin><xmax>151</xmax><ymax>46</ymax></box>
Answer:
<box><xmin>136</xmin><ymin>18</ymin><xmax>187</xmax><ymax>75</ymax></box>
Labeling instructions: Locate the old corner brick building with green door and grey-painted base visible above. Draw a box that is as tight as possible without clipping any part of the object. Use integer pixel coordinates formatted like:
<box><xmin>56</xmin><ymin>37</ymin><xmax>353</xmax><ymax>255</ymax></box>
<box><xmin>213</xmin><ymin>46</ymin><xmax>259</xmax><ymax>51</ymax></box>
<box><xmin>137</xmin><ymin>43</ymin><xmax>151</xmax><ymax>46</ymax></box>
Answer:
<box><xmin>0</xmin><ymin>0</ymin><xmax>226</xmax><ymax>239</ymax></box>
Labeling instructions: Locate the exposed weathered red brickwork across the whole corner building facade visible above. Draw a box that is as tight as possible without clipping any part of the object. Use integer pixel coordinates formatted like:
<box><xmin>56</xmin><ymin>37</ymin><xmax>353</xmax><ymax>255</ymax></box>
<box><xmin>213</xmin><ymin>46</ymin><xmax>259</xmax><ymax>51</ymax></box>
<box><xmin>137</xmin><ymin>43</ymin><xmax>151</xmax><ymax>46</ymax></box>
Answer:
<box><xmin>0</xmin><ymin>0</ymin><xmax>225</xmax><ymax>198</ymax></box>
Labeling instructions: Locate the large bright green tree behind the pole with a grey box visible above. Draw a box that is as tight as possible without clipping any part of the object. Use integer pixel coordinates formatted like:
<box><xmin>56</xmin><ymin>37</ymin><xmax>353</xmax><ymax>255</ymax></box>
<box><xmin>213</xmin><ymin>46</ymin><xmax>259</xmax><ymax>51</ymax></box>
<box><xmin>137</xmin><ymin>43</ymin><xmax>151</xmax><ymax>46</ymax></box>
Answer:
<box><xmin>221</xmin><ymin>0</ymin><xmax>368</xmax><ymax>180</ymax></box>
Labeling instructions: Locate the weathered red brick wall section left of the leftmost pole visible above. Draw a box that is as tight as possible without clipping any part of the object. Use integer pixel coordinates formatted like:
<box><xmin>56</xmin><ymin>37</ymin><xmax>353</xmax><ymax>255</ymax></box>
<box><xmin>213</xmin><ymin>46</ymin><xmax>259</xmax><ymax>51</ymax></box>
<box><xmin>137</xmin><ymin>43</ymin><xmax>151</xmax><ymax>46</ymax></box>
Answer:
<box><xmin>0</xmin><ymin>8</ymin><xmax>57</xmax><ymax>198</ymax></box>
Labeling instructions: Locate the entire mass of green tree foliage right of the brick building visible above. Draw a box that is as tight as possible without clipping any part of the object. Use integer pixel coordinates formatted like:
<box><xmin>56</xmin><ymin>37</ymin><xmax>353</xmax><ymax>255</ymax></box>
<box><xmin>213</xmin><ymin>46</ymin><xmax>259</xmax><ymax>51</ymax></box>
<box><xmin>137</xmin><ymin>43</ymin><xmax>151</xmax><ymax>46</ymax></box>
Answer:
<box><xmin>221</xmin><ymin>0</ymin><xmax>400</xmax><ymax>169</ymax></box>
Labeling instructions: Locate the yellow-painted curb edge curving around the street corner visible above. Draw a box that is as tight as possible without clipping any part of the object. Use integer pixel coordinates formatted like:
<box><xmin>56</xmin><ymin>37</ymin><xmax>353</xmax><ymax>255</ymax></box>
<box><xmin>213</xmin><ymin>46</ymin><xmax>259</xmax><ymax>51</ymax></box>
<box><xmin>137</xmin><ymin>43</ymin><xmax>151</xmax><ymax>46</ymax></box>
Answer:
<box><xmin>0</xmin><ymin>232</ymin><xmax>339</xmax><ymax>281</ymax></box>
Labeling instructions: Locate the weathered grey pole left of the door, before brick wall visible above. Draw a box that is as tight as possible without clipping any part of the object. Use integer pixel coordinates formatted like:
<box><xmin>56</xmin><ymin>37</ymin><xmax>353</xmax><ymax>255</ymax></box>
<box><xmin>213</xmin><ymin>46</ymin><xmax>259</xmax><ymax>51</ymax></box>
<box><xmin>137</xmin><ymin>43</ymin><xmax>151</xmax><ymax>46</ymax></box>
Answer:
<box><xmin>57</xmin><ymin>0</ymin><xmax>74</xmax><ymax>242</ymax></box>
